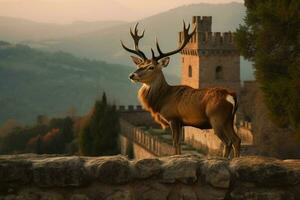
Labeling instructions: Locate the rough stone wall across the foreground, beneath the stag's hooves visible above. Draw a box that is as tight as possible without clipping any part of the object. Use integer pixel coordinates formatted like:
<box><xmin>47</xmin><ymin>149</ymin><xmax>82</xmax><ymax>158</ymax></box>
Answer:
<box><xmin>0</xmin><ymin>154</ymin><xmax>300</xmax><ymax>200</ymax></box>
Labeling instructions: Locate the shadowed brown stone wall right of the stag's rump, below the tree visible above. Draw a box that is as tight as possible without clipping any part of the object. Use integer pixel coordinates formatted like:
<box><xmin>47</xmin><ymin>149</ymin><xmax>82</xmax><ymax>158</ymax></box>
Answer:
<box><xmin>238</xmin><ymin>81</ymin><xmax>300</xmax><ymax>158</ymax></box>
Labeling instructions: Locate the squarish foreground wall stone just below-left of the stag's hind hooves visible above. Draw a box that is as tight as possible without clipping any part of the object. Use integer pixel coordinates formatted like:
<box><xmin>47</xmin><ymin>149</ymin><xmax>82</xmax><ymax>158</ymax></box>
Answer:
<box><xmin>201</xmin><ymin>159</ymin><xmax>231</xmax><ymax>188</ymax></box>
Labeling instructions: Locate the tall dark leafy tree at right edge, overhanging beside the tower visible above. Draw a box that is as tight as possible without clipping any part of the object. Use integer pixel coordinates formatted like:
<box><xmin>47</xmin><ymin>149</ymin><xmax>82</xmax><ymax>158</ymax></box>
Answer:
<box><xmin>235</xmin><ymin>0</ymin><xmax>300</xmax><ymax>136</ymax></box>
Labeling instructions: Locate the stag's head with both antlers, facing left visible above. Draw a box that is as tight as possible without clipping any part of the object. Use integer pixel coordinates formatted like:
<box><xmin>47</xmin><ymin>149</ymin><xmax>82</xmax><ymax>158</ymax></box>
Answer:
<box><xmin>121</xmin><ymin>22</ymin><xmax>196</xmax><ymax>83</ymax></box>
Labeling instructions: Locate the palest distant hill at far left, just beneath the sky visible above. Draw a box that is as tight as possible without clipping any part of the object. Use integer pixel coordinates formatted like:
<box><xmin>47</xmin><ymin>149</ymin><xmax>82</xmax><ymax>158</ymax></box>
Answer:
<box><xmin>0</xmin><ymin>16</ymin><xmax>125</xmax><ymax>42</ymax></box>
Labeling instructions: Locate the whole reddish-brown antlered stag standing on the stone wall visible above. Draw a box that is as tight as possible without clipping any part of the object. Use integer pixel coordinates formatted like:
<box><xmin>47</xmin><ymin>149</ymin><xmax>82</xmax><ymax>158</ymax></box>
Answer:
<box><xmin>121</xmin><ymin>22</ymin><xmax>241</xmax><ymax>158</ymax></box>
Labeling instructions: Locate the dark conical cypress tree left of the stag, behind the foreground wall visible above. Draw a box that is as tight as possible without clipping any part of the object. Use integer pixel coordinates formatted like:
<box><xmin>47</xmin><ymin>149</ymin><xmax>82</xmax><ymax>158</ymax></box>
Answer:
<box><xmin>79</xmin><ymin>93</ymin><xmax>120</xmax><ymax>156</ymax></box>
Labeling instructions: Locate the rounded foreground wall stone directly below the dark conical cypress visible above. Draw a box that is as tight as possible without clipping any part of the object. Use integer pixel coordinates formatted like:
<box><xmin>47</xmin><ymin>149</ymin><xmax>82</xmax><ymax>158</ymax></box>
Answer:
<box><xmin>85</xmin><ymin>156</ymin><xmax>132</xmax><ymax>184</ymax></box>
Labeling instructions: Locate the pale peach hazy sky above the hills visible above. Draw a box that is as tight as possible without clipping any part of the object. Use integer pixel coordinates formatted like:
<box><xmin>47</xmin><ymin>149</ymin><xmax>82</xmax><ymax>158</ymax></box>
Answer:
<box><xmin>0</xmin><ymin>0</ymin><xmax>243</xmax><ymax>23</ymax></box>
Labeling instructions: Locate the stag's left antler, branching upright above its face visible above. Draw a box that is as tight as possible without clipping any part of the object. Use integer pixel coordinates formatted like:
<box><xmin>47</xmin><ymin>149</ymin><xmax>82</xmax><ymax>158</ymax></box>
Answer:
<box><xmin>121</xmin><ymin>23</ymin><xmax>147</xmax><ymax>60</ymax></box>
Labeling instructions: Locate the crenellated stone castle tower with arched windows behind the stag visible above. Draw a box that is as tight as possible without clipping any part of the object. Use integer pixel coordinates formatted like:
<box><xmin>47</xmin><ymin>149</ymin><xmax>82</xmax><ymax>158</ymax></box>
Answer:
<box><xmin>179</xmin><ymin>16</ymin><xmax>240</xmax><ymax>92</ymax></box>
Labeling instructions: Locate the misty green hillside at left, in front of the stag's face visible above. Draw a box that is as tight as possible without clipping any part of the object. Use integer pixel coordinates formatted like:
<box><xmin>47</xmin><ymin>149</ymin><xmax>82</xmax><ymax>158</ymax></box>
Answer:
<box><xmin>0</xmin><ymin>42</ymin><xmax>136</xmax><ymax>123</ymax></box>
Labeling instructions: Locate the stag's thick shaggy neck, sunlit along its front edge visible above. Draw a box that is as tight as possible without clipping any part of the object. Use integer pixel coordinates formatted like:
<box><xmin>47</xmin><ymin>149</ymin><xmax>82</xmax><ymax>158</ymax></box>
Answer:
<box><xmin>138</xmin><ymin>72</ymin><xmax>170</xmax><ymax>113</ymax></box>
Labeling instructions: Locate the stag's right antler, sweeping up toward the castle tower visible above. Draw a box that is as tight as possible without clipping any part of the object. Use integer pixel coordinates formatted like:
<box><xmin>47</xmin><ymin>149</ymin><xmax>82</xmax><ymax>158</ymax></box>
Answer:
<box><xmin>151</xmin><ymin>21</ymin><xmax>196</xmax><ymax>61</ymax></box>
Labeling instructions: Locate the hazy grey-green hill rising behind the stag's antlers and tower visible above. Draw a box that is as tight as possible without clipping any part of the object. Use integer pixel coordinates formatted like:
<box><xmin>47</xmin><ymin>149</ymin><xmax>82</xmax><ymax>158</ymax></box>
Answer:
<box><xmin>22</xmin><ymin>3</ymin><xmax>252</xmax><ymax>80</ymax></box>
